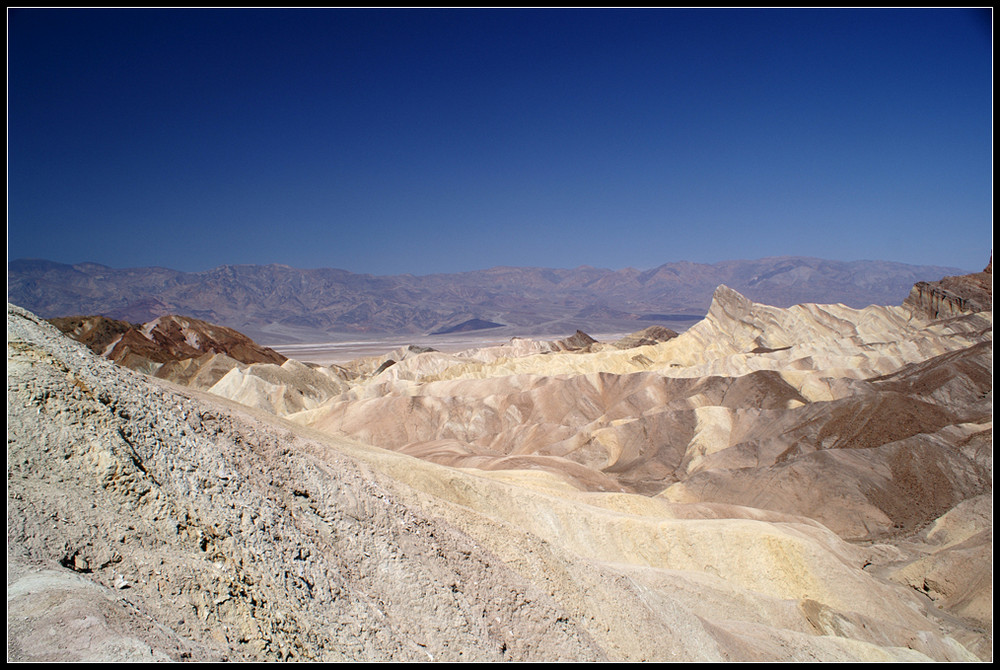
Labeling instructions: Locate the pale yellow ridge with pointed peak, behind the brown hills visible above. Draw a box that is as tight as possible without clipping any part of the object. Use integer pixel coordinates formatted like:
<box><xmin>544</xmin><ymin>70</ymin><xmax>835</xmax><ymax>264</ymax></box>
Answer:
<box><xmin>380</xmin><ymin>287</ymin><xmax>992</xmax><ymax>400</ymax></box>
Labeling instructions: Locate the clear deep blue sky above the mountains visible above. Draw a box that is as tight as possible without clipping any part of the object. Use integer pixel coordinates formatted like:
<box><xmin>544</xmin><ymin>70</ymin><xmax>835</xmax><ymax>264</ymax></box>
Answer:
<box><xmin>7</xmin><ymin>9</ymin><xmax>993</xmax><ymax>274</ymax></box>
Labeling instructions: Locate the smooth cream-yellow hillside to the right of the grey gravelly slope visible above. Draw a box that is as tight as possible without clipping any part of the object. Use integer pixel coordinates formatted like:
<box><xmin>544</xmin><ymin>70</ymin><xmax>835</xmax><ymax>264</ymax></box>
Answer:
<box><xmin>292</xmin><ymin>422</ymin><xmax>980</xmax><ymax>660</ymax></box>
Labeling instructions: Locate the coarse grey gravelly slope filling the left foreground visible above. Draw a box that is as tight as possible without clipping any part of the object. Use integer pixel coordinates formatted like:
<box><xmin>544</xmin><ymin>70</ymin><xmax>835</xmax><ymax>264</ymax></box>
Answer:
<box><xmin>7</xmin><ymin>307</ymin><xmax>603</xmax><ymax>661</ymax></box>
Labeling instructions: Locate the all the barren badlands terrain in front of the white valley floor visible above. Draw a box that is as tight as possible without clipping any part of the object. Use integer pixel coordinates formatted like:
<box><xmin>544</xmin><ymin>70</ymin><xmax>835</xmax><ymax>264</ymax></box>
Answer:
<box><xmin>7</xmin><ymin>262</ymin><xmax>992</xmax><ymax>661</ymax></box>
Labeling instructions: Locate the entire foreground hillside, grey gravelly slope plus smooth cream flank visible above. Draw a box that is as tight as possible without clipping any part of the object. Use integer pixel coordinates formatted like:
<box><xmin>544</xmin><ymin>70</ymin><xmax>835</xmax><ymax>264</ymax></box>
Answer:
<box><xmin>7</xmin><ymin>306</ymin><xmax>991</xmax><ymax>661</ymax></box>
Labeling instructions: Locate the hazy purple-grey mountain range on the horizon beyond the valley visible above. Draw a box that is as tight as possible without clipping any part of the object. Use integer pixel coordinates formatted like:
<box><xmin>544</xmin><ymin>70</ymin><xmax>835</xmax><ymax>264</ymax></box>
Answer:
<box><xmin>7</xmin><ymin>257</ymin><xmax>965</xmax><ymax>344</ymax></box>
